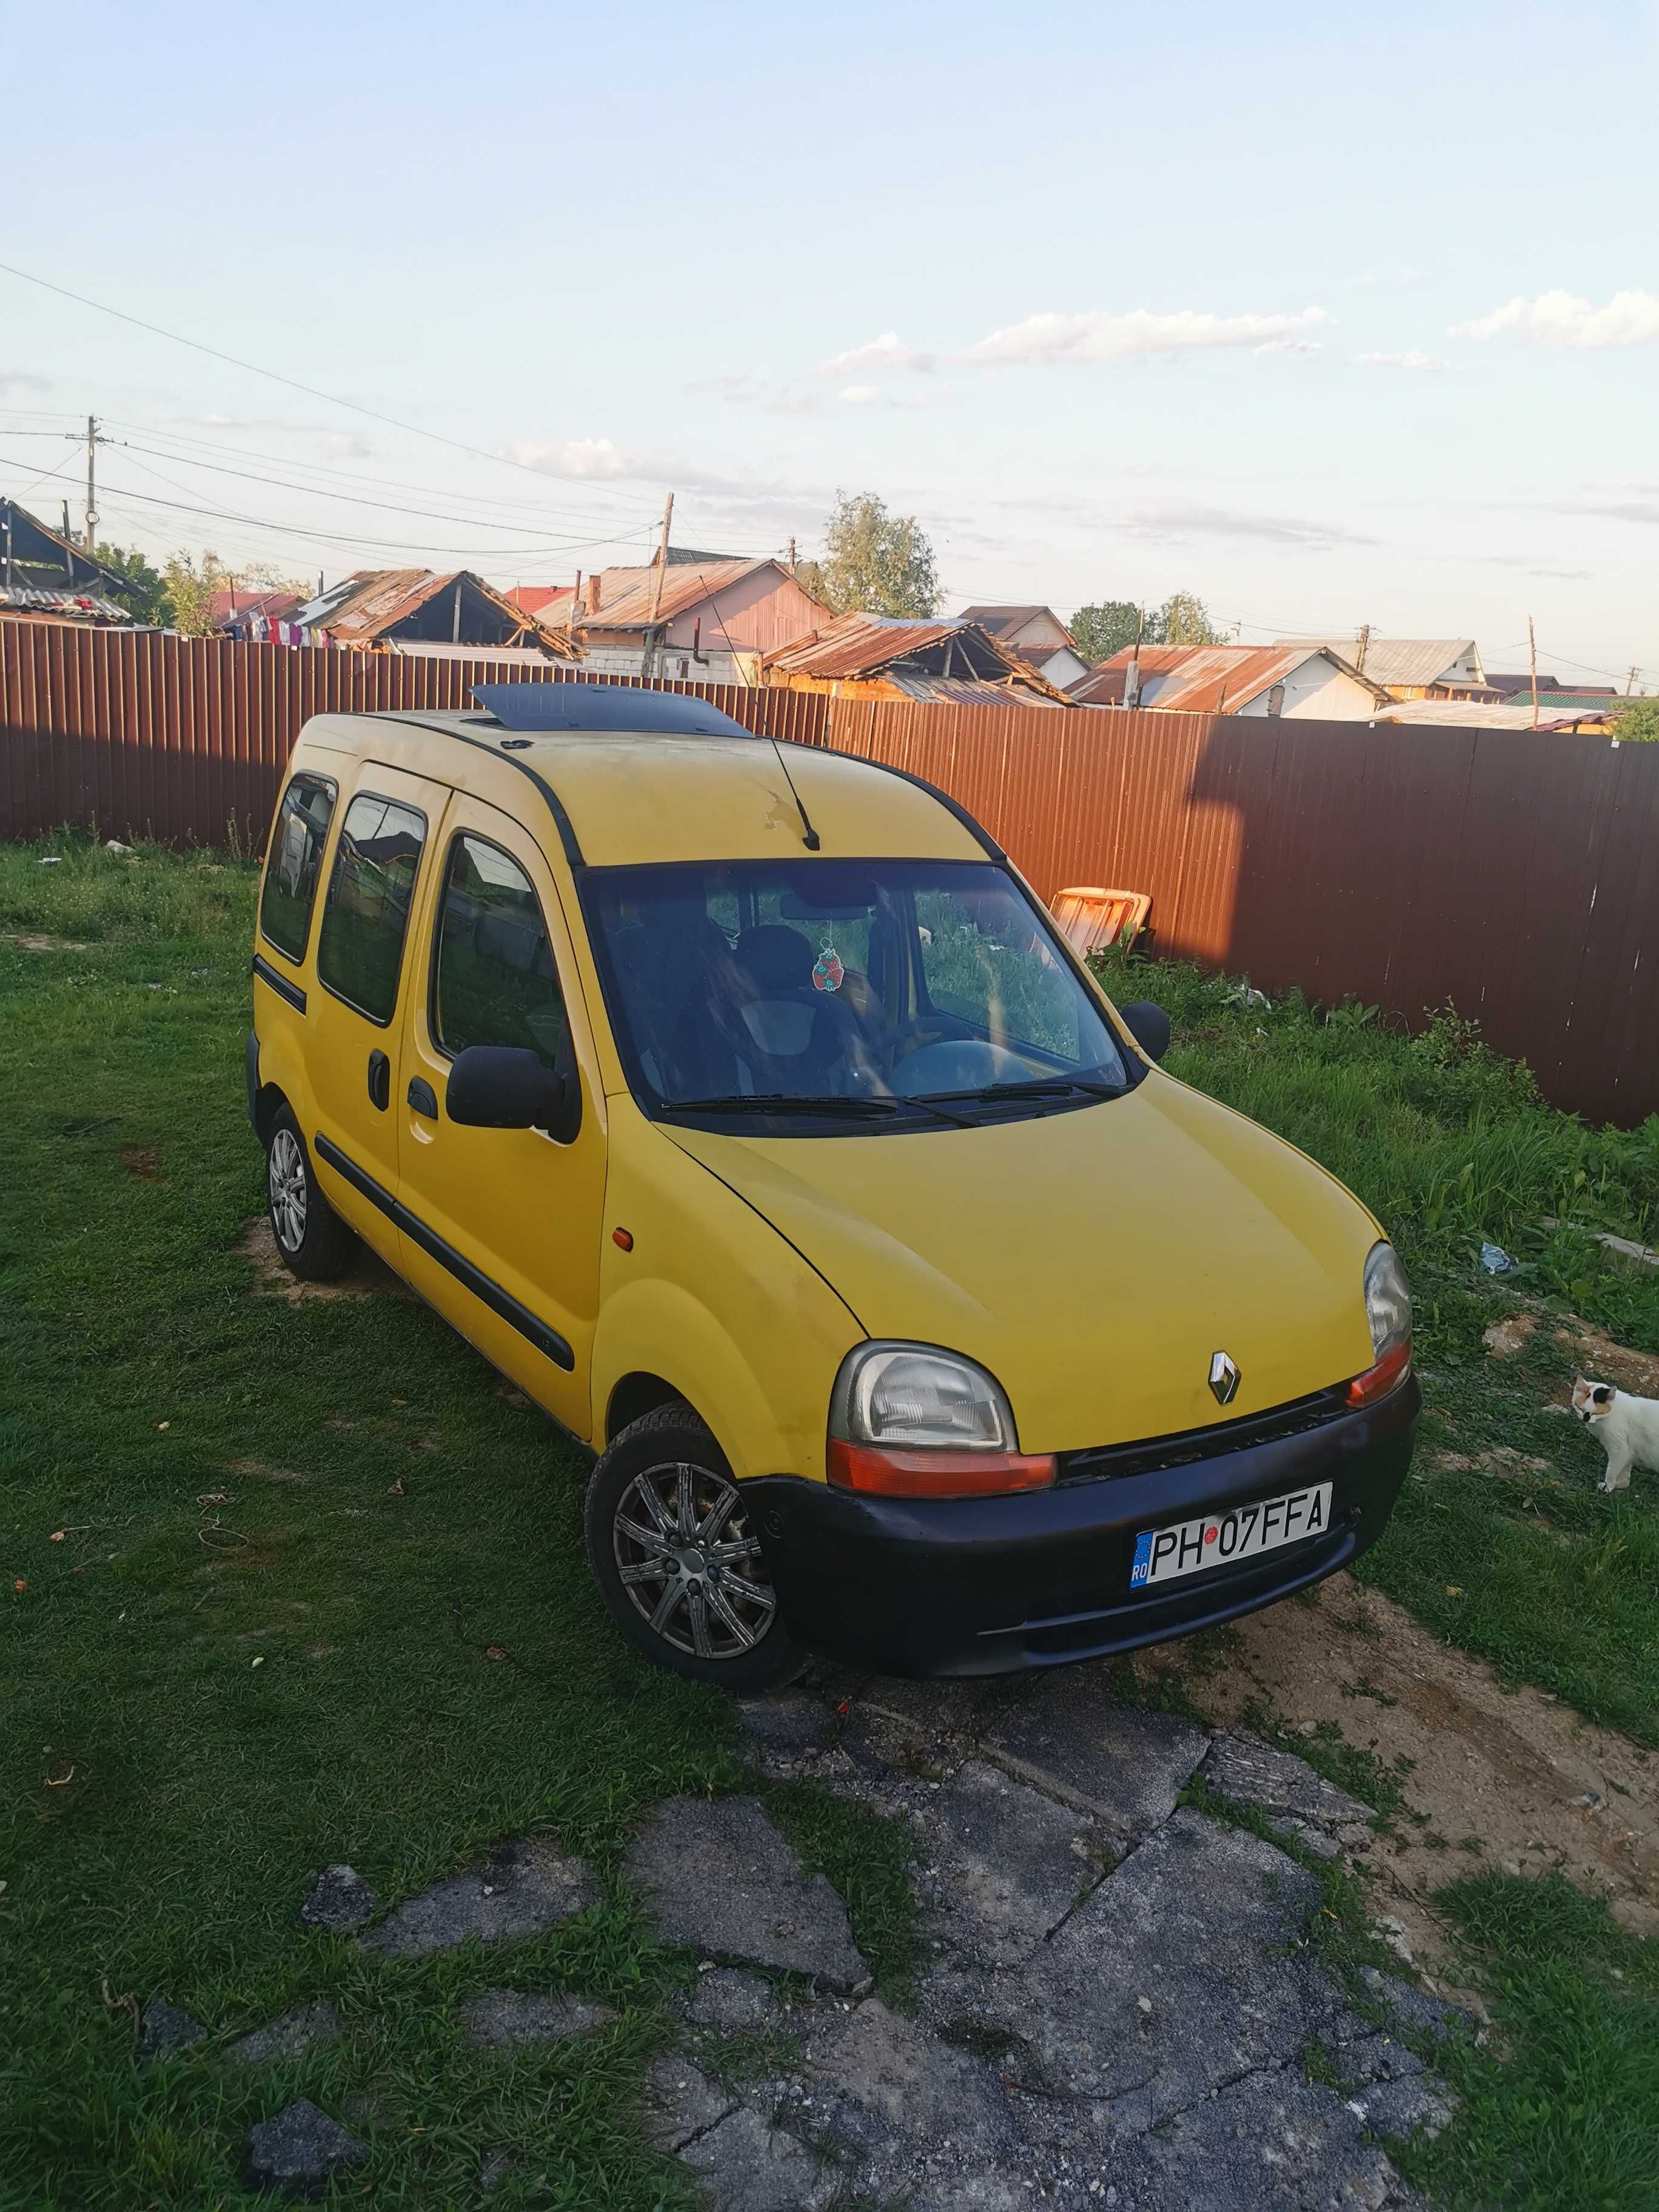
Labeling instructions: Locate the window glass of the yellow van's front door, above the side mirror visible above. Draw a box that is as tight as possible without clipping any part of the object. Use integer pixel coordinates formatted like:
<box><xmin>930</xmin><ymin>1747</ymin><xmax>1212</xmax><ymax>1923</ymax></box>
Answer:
<box><xmin>431</xmin><ymin>834</ymin><xmax>566</xmax><ymax>1068</ymax></box>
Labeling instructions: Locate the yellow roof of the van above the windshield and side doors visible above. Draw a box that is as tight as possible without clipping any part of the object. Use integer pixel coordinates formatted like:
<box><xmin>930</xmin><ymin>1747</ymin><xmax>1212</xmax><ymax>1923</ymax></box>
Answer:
<box><xmin>301</xmin><ymin>710</ymin><xmax>996</xmax><ymax>867</ymax></box>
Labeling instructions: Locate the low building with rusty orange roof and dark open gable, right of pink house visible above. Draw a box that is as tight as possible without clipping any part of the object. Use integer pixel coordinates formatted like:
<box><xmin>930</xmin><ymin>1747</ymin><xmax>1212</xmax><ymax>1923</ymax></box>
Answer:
<box><xmin>761</xmin><ymin>612</ymin><xmax>1073</xmax><ymax>706</ymax></box>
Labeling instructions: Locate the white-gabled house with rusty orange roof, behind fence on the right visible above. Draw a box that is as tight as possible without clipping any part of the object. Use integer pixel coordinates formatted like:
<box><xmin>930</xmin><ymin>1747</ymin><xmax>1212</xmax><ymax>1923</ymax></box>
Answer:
<box><xmin>1071</xmin><ymin>644</ymin><xmax>1393</xmax><ymax>721</ymax></box>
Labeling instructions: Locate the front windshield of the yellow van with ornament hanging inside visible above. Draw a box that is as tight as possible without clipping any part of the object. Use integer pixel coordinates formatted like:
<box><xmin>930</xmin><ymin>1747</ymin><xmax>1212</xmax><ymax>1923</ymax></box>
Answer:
<box><xmin>586</xmin><ymin>858</ymin><xmax>1133</xmax><ymax>1128</ymax></box>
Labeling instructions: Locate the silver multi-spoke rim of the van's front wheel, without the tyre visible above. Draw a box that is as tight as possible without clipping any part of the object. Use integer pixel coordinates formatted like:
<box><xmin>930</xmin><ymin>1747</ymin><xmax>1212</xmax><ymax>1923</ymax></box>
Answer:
<box><xmin>611</xmin><ymin>1460</ymin><xmax>779</xmax><ymax>1659</ymax></box>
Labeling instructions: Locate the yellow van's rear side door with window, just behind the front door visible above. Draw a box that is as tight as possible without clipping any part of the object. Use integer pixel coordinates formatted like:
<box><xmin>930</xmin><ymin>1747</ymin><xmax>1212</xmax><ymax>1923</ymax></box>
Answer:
<box><xmin>305</xmin><ymin>761</ymin><xmax>451</xmax><ymax>1265</ymax></box>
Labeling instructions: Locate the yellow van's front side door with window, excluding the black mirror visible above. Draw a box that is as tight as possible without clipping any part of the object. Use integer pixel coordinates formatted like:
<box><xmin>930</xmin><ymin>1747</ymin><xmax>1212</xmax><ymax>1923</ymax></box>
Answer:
<box><xmin>398</xmin><ymin>794</ymin><xmax>606</xmax><ymax>1438</ymax></box>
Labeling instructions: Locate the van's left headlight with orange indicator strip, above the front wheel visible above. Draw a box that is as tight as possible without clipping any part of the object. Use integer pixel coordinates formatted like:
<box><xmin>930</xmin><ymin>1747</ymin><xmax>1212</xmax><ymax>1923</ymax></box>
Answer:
<box><xmin>827</xmin><ymin>1342</ymin><xmax>1055</xmax><ymax>1498</ymax></box>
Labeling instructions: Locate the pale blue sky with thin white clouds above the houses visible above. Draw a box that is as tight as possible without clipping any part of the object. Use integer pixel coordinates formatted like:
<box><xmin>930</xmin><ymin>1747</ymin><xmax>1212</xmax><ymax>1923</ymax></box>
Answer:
<box><xmin>0</xmin><ymin>0</ymin><xmax>1659</xmax><ymax>690</ymax></box>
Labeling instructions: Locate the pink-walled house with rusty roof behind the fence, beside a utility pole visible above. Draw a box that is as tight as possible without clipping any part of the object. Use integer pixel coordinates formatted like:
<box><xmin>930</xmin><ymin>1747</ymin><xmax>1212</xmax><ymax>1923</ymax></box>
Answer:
<box><xmin>575</xmin><ymin>549</ymin><xmax>834</xmax><ymax>683</ymax></box>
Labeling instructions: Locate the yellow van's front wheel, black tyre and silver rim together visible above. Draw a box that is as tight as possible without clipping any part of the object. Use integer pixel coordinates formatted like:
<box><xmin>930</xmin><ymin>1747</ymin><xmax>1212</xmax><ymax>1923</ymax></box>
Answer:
<box><xmin>586</xmin><ymin>1404</ymin><xmax>805</xmax><ymax>1692</ymax></box>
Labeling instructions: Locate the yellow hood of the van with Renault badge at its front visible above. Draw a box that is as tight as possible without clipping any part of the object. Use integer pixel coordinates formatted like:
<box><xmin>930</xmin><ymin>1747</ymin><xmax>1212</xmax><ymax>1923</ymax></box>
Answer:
<box><xmin>672</xmin><ymin>1075</ymin><xmax>1378</xmax><ymax>1451</ymax></box>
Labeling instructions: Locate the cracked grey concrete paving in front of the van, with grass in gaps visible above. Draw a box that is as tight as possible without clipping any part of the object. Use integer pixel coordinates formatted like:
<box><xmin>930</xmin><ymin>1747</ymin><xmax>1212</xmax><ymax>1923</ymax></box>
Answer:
<box><xmin>650</xmin><ymin>1668</ymin><xmax>1455</xmax><ymax>2212</ymax></box>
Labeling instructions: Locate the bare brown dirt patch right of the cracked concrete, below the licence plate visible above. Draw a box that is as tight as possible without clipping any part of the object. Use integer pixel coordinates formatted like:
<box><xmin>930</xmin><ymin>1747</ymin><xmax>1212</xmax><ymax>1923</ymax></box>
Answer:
<box><xmin>1188</xmin><ymin>1575</ymin><xmax>1659</xmax><ymax>1957</ymax></box>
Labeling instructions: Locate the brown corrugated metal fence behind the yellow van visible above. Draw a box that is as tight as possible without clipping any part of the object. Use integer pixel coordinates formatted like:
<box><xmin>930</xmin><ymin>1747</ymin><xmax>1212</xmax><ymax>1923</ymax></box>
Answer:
<box><xmin>0</xmin><ymin>622</ymin><xmax>1659</xmax><ymax>1124</ymax></box>
